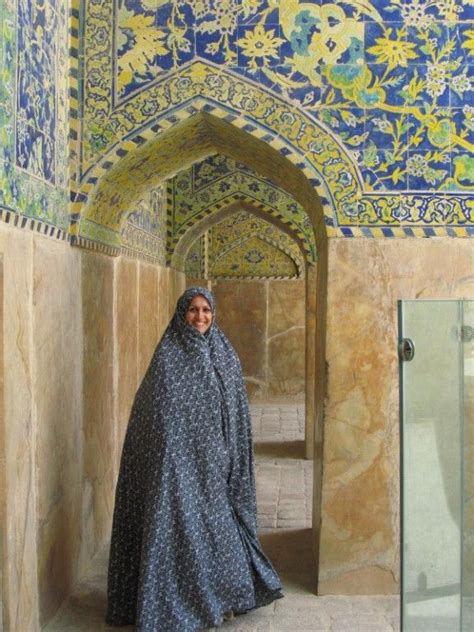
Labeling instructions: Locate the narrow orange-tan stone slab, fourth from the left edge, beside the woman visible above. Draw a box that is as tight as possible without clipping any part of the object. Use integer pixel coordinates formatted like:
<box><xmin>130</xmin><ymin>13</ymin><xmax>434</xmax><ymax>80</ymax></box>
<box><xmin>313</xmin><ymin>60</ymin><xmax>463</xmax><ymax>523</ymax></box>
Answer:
<box><xmin>115</xmin><ymin>257</ymin><xmax>139</xmax><ymax>472</ymax></box>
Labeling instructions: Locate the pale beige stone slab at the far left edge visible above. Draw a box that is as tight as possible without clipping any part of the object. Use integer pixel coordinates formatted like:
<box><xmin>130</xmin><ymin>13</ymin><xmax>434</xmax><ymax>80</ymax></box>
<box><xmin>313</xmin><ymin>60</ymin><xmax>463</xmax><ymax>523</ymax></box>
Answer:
<box><xmin>0</xmin><ymin>225</ymin><xmax>39</xmax><ymax>632</ymax></box>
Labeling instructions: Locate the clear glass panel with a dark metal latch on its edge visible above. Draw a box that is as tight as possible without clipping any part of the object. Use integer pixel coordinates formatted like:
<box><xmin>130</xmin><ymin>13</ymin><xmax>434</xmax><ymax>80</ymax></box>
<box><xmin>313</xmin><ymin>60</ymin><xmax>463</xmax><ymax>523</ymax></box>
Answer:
<box><xmin>399</xmin><ymin>301</ymin><xmax>462</xmax><ymax>632</ymax></box>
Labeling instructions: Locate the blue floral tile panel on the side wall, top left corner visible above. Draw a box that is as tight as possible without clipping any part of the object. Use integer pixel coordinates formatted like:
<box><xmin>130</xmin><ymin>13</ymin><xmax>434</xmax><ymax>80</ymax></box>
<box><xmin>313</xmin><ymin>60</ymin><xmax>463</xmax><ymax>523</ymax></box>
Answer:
<box><xmin>0</xmin><ymin>0</ymin><xmax>70</xmax><ymax>231</ymax></box>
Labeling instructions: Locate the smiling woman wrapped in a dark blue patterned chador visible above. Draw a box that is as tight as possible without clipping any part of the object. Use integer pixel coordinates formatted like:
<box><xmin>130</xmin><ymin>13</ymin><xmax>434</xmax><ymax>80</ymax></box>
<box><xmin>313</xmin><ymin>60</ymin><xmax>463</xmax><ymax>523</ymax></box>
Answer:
<box><xmin>107</xmin><ymin>287</ymin><xmax>282</xmax><ymax>632</ymax></box>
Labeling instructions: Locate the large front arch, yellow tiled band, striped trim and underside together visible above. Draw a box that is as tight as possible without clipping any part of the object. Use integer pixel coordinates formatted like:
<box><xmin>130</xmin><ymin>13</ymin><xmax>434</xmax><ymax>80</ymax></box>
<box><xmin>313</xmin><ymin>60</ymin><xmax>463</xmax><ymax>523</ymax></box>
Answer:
<box><xmin>75</xmin><ymin>60</ymin><xmax>362</xmax><ymax>246</ymax></box>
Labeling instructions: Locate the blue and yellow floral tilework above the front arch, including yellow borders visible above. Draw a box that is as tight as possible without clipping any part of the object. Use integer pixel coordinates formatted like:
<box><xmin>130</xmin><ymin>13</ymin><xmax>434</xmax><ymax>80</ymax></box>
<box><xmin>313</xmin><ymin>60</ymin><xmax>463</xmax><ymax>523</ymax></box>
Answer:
<box><xmin>76</xmin><ymin>0</ymin><xmax>474</xmax><ymax>241</ymax></box>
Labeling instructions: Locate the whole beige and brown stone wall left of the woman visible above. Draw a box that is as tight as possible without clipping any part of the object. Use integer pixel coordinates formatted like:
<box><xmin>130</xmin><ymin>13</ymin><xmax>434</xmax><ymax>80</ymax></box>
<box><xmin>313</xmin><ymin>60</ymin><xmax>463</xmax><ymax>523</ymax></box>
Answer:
<box><xmin>0</xmin><ymin>225</ymin><xmax>184</xmax><ymax>632</ymax></box>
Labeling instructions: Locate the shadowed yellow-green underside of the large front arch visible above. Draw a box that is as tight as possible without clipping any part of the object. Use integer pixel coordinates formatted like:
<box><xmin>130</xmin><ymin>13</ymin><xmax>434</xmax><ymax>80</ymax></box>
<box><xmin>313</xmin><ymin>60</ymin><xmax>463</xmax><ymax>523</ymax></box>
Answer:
<box><xmin>79</xmin><ymin>112</ymin><xmax>325</xmax><ymax>246</ymax></box>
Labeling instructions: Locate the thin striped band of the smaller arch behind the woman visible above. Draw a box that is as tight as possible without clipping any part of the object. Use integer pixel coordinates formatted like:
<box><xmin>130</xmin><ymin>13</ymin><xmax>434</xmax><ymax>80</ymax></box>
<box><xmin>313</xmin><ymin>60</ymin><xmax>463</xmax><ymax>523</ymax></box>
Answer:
<box><xmin>168</xmin><ymin>196</ymin><xmax>313</xmax><ymax>270</ymax></box>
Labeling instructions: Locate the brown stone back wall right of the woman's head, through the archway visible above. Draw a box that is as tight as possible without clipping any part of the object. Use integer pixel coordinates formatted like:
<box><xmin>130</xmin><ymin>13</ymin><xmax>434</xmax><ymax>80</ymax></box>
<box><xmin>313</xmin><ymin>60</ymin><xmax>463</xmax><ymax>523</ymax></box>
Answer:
<box><xmin>211</xmin><ymin>279</ymin><xmax>305</xmax><ymax>402</ymax></box>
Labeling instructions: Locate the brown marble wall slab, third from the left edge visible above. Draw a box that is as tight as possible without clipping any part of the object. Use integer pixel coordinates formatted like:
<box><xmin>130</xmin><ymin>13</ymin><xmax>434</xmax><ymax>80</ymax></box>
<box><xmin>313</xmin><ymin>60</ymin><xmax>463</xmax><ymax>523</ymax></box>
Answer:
<box><xmin>81</xmin><ymin>251</ymin><xmax>116</xmax><ymax>567</ymax></box>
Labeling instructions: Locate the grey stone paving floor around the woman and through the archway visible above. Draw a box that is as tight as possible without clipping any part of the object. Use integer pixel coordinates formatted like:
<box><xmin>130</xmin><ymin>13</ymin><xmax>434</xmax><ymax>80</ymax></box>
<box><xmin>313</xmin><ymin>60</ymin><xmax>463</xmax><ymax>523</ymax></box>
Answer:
<box><xmin>45</xmin><ymin>405</ymin><xmax>399</xmax><ymax>632</ymax></box>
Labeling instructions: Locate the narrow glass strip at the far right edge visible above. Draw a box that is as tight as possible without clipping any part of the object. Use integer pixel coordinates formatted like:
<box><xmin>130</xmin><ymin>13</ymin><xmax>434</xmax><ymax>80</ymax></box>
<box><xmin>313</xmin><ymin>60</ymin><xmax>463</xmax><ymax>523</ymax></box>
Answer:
<box><xmin>461</xmin><ymin>301</ymin><xmax>474</xmax><ymax>632</ymax></box>
